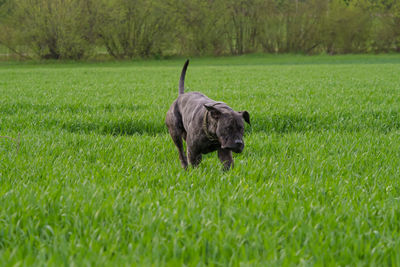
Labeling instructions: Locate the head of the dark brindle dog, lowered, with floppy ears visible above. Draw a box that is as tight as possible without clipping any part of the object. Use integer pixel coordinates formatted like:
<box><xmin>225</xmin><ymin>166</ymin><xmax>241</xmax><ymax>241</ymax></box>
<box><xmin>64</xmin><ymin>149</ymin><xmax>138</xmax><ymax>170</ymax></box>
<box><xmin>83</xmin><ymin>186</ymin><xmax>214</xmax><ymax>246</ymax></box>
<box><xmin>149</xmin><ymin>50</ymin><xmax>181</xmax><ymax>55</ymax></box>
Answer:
<box><xmin>204</xmin><ymin>103</ymin><xmax>250</xmax><ymax>153</ymax></box>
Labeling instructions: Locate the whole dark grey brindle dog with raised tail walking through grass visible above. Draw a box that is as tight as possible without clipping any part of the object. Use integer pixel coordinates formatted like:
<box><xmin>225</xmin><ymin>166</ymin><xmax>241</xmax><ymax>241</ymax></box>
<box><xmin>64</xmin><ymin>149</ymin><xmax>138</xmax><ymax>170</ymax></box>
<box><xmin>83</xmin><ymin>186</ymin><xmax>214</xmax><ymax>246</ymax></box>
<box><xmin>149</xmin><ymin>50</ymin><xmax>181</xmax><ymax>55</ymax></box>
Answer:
<box><xmin>165</xmin><ymin>60</ymin><xmax>250</xmax><ymax>170</ymax></box>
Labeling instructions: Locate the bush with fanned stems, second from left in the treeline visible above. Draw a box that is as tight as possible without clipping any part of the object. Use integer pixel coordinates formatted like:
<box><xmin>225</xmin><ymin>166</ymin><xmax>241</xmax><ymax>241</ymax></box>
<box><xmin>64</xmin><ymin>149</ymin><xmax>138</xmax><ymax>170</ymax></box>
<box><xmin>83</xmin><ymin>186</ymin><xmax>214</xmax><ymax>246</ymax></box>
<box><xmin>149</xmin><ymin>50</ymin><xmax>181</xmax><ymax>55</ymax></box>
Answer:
<box><xmin>96</xmin><ymin>0</ymin><xmax>172</xmax><ymax>59</ymax></box>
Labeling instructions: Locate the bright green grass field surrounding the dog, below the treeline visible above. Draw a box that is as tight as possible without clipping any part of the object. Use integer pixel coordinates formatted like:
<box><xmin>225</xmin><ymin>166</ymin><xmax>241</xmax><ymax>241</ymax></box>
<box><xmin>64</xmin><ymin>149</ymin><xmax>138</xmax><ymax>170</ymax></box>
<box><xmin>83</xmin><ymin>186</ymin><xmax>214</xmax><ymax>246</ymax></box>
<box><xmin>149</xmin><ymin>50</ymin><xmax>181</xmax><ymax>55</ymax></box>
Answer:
<box><xmin>0</xmin><ymin>55</ymin><xmax>400</xmax><ymax>266</ymax></box>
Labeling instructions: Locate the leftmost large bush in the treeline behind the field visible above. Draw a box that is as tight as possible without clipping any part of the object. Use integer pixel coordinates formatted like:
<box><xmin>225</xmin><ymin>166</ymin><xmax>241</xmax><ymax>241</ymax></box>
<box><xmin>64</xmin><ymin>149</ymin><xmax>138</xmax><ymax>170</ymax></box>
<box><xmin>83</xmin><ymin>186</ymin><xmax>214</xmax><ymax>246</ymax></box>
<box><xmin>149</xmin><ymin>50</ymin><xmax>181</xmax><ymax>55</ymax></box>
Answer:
<box><xmin>7</xmin><ymin>0</ymin><xmax>93</xmax><ymax>59</ymax></box>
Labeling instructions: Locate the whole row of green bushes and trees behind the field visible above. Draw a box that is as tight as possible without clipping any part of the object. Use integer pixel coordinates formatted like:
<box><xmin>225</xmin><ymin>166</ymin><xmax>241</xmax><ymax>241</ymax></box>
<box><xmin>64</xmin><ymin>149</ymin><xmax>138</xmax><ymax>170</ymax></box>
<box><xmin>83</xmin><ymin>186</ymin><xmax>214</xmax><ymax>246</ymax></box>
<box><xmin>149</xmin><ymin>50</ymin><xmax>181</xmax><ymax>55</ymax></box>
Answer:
<box><xmin>0</xmin><ymin>0</ymin><xmax>400</xmax><ymax>59</ymax></box>
